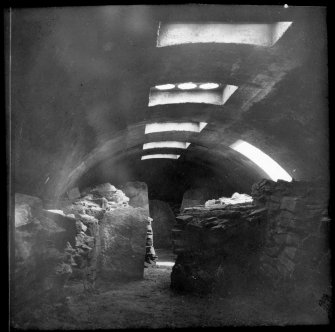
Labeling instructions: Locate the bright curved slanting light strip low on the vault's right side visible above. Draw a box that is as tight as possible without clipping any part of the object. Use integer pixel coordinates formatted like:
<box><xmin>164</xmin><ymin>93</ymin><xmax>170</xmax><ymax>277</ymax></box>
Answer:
<box><xmin>230</xmin><ymin>140</ymin><xmax>292</xmax><ymax>182</ymax></box>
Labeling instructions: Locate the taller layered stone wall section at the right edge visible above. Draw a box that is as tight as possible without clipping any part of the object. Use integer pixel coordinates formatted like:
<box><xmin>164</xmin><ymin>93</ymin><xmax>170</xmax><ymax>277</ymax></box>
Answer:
<box><xmin>252</xmin><ymin>180</ymin><xmax>331</xmax><ymax>303</ymax></box>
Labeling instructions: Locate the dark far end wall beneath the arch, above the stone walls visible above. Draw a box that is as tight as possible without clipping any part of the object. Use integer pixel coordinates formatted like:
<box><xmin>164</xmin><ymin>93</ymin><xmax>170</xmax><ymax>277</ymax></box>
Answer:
<box><xmin>75</xmin><ymin>160</ymin><xmax>239</xmax><ymax>204</ymax></box>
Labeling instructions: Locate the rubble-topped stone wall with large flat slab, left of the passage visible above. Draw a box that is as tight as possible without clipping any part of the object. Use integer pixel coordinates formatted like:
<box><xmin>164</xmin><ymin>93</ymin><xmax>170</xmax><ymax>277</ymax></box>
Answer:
<box><xmin>62</xmin><ymin>183</ymin><xmax>148</xmax><ymax>290</ymax></box>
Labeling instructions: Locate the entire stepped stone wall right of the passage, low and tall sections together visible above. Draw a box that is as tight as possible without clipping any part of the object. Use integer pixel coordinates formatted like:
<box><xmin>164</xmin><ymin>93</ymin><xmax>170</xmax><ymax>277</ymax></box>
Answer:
<box><xmin>171</xmin><ymin>180</ymin><xmax>331</xmax><ymax>305</ymax></box>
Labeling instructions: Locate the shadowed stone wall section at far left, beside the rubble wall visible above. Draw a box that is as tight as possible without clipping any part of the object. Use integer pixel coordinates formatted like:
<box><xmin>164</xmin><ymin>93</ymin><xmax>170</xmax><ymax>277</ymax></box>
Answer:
<box><xmin>11</xmin><ymin>194</ymin><xmax>74</xmax><ymax>328</ymax></box>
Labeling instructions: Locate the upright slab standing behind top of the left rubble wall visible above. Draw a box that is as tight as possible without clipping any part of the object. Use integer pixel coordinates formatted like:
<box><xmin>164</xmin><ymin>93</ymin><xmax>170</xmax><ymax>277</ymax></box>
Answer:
<box><xmin>122</xmin><ymin>181</ymin><xmax>149</xmax><ymax>215</ymax></box>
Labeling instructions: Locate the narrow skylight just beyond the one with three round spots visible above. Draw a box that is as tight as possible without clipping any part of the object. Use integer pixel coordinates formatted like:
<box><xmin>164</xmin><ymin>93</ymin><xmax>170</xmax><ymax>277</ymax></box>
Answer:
<box><xmin>145</xmin><ymin>122</ymin><xmax>207</xmax><ymax>134</ymax></box>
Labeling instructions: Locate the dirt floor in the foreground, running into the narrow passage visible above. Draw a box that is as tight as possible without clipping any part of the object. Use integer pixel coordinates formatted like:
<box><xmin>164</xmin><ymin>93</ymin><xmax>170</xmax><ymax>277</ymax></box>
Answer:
<box><xmin>24</xmin><ymin>250</ymin><xmax>328</xmax><ymax>330</ymax></box>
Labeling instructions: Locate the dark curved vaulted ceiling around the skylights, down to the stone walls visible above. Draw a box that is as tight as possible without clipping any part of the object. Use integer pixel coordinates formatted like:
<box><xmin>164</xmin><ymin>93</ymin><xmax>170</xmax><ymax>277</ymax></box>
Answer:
<box><xmin>9</xmin><ymin>5</ymin><xmax>328</xmax><ymax>199</ymax></box>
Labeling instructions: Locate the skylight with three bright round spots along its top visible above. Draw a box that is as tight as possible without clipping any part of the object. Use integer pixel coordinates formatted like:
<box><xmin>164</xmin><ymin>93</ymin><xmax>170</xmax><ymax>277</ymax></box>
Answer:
<box><xmin>149</xmin><ymin>82</ymin><xmax>238</xmax><ymax>107</ymax></box>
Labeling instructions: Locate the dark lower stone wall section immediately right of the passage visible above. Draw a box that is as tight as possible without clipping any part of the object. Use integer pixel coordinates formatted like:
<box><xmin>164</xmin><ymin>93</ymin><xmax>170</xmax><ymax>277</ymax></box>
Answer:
<box><xmin>171</xmin><ymin>203</ymin><xmax>265</xmax><ymax>294</ymax></box>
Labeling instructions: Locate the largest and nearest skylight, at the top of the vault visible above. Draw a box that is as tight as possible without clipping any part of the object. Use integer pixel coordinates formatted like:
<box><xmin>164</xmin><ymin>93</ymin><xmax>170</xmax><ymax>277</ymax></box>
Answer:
<box><xmin>157</xmin><ymin>22</ymin><xmax>292</xmax><ymax>47</ymax></box>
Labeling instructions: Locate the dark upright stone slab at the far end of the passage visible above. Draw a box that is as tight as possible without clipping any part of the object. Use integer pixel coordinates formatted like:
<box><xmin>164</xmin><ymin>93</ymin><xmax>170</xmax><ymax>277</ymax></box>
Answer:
<box><xmin>150</xmin><ymin>200</ymin><xmax>175</xmax><ymax>248</ymax></box>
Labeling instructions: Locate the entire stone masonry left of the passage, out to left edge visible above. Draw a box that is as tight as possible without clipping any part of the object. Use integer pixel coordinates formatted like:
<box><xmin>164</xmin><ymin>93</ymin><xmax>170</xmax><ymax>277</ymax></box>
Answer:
<box><xmin>12</xmin><ymin>183</ymin><xmax>154</xmax><ymax>327</ymax></box>
